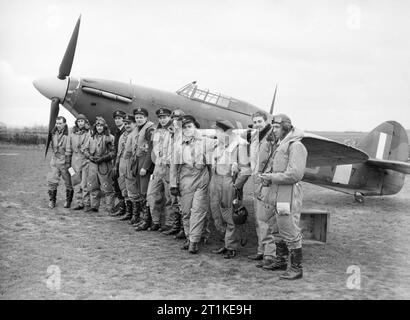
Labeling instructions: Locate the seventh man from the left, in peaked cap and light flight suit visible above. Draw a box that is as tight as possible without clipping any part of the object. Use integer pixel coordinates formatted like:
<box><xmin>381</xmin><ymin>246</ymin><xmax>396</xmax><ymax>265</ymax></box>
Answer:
<box><xmin>147</xmin><ymin>108</ymin><xmax>179</xmax><ymax>234</ymax></box>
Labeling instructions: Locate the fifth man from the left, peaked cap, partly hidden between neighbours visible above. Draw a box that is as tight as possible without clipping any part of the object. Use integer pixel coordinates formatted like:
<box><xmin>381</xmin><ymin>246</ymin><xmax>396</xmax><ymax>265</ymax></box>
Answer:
<box><xmin>113</xmin><ymin>114</ymin><xmax>138</xmax><ymax>220</ymax></box>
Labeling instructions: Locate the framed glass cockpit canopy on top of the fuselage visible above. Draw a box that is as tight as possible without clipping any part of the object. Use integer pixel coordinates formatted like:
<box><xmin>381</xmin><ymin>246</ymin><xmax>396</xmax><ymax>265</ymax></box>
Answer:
<box><xmin>177</xmin><ymin>81</ymin><xmax>234</xmax><ymax>108</ymax></box>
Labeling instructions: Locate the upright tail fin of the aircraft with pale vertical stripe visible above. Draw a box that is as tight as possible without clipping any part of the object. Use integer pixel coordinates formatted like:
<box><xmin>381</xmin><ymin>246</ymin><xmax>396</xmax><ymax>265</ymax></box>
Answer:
<box><xmin>358</xmin><ymin>121</ymin><xmax>410</xmax><ymax>164</ymax></box>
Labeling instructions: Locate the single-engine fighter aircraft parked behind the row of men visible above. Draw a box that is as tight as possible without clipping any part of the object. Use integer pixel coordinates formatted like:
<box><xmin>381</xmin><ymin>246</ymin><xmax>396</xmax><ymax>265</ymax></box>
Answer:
<box><xmin>33</xmin><ymin>16</ymin><xmax>410</xmax><ymax>202</ymax></box>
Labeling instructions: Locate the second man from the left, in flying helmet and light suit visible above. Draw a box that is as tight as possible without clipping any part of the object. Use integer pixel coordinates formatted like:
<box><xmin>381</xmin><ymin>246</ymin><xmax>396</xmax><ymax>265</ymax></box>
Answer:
<box><xmin>66</xmin><ymin>114</ymin><xmax>90</xmax><ymax>210</ymax></box>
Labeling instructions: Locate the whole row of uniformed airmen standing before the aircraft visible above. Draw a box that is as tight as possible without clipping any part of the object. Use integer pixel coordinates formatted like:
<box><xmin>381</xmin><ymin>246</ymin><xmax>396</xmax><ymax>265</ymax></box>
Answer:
<box><xmin>47</xmin><ymin>108</ymin><xmax>307</xmax><ymax>280</ymax></box>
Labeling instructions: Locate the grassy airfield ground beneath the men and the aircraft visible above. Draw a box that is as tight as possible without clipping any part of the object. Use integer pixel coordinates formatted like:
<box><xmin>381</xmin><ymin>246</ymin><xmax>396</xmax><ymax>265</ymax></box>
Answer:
<box><xmin>0</xmin><ymin>145</ymin><xmax>410</xmax><ymax>300</ymax></box>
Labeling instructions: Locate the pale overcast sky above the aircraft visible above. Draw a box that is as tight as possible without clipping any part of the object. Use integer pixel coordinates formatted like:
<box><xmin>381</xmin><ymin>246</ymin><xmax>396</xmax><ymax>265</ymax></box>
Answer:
<box><xmin>0</xmin><ymin>0</ymin><xmax>410</xmax><ymax>131</ymax></box>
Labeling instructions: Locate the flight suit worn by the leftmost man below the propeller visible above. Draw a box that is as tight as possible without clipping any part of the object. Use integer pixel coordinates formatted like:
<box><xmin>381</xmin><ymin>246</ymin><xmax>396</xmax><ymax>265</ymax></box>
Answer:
<box><xmin>47</xmin><ymin>126</ymin><xmax>73</xmax><ymax>192</ymax></box>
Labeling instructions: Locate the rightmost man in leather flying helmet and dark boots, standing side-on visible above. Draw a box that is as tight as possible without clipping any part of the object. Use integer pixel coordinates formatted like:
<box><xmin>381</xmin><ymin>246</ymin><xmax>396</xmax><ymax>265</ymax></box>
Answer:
<box><xmin>258</xmin><ymin>114</ymin><xmax>307</xmax><ymax>280</ymax></box>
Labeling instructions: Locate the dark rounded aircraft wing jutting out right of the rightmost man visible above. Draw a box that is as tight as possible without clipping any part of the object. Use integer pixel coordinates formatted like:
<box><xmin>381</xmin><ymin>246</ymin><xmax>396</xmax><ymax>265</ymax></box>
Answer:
<box><xmin>302</xmin><ymin>132</ymin><xmax>369</xmax><ymax>168</ymax></box>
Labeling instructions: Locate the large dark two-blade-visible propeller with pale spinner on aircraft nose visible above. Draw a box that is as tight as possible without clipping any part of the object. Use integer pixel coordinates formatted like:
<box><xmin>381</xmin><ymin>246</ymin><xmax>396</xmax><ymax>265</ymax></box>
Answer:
<box><xmin>44</xmin><ymin>15</ymin><xmax>81</xmax><ymax>156</ymax></box>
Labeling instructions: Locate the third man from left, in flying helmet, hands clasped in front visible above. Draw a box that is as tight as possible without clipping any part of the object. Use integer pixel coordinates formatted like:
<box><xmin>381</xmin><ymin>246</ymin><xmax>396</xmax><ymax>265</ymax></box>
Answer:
<box><xmin>84</xmin><ymin>117</ymin><xmax>115</xmax><ymax>213</ymax></box>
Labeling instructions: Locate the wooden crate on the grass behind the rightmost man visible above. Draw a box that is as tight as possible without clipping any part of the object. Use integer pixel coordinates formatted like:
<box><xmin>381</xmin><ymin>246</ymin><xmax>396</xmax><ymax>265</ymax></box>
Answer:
<box><xmin>299</xmin><ymin>209</ymin><xmax>330</xmax><ymax>243</ymax></box>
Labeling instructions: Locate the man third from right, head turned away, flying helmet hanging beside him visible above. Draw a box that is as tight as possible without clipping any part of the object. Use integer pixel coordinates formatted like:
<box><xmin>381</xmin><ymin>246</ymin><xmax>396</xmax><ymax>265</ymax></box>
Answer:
<box><xmin>209</xmin><ymin>120</ymin><xmax>250</xmax><ymax>259</ymax></box>
